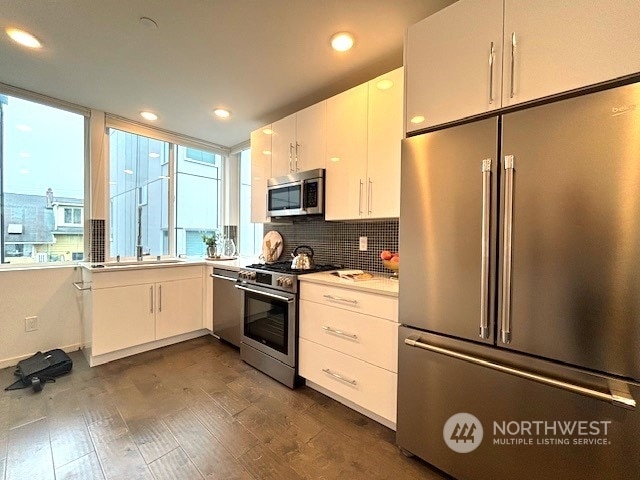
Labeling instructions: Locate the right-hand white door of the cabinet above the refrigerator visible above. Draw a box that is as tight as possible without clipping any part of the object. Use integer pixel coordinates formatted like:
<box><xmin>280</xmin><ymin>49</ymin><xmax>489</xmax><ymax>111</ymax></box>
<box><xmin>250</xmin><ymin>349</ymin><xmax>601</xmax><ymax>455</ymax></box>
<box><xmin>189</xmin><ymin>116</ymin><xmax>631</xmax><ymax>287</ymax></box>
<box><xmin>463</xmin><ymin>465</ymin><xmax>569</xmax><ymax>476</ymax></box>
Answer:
<box><xmin>502</xmin><ymin>0</ymin><xmax>640</xmax><ymax>106</ymax></box>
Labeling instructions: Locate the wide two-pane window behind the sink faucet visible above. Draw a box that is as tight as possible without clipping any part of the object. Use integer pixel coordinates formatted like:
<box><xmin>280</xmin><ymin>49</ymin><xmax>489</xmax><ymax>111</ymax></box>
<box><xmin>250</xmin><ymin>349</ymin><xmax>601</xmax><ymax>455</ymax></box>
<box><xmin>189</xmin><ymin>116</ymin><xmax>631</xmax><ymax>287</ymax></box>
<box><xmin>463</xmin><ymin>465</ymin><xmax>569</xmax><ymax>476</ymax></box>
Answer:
<box><xmin>109</xmin><ymin>128</ymin><xmax>224</xmax><ymax>257</ymax></box>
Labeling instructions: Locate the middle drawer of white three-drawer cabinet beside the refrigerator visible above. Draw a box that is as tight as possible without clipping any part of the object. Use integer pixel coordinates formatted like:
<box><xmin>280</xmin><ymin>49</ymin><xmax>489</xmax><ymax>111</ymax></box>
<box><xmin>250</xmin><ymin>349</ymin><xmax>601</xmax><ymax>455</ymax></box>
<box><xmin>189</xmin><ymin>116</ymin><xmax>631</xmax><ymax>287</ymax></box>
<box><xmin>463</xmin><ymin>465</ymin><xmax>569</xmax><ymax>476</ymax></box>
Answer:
<box><xmin>300</xmin><ymin>300</ymin><xmax>398</xmax><ymax>373</ymax></box>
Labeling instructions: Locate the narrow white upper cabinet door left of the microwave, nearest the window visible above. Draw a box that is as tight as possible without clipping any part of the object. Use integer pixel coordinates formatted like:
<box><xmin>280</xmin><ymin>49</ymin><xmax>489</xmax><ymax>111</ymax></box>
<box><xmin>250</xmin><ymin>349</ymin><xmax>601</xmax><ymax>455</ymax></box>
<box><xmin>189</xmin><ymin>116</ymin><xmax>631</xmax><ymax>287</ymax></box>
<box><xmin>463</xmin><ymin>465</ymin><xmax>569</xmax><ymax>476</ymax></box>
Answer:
<box><xmin>251</xmin><ymin>125</ymin><xmax>271</xmax><ymax>223</ymax></box>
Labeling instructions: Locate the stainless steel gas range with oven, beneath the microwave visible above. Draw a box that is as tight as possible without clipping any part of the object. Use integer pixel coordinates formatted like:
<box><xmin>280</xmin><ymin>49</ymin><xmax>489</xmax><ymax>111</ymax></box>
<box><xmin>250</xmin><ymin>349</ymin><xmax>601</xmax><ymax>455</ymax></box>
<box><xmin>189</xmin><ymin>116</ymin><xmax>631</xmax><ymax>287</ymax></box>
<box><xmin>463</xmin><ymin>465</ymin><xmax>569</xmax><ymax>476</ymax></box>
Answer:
<box><xmin>236</xmin><ymin>262</ymin><xmax>340</xmax><ymax>388</ymax></box>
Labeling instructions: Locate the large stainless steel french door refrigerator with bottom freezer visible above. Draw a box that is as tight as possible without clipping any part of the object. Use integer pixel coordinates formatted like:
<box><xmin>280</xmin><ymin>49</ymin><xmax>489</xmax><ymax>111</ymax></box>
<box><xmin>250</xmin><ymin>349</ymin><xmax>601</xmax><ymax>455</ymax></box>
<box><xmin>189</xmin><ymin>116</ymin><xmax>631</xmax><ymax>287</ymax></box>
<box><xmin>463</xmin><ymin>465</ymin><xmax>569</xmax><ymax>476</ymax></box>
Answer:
<box><xmin>397</xmin><ymin>80</ymin><xmax>640</xmax><ymax>479</ymax></box>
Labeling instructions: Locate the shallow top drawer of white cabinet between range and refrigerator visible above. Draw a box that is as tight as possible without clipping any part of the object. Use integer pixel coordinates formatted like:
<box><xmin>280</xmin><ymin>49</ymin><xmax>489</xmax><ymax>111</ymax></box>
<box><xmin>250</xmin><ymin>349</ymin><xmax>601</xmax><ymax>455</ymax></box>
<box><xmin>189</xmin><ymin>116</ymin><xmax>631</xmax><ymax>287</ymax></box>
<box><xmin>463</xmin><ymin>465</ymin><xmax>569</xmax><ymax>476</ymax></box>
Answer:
<box><xmin>300</xmin><ymin>282</ymin><xmax>398</xmax><ymax>322</ymax></box>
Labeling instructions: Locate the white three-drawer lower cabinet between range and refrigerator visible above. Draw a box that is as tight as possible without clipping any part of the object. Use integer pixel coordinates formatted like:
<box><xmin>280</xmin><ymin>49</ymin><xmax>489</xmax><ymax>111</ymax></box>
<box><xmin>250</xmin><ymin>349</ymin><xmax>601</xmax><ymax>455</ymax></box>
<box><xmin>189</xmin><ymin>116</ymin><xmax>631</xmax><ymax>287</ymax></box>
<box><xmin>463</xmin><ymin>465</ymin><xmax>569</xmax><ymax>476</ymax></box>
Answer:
<box><xmin>299</xmin><ymin>282</ymin><xmax>398</xmax><ymax>428</ymax></box>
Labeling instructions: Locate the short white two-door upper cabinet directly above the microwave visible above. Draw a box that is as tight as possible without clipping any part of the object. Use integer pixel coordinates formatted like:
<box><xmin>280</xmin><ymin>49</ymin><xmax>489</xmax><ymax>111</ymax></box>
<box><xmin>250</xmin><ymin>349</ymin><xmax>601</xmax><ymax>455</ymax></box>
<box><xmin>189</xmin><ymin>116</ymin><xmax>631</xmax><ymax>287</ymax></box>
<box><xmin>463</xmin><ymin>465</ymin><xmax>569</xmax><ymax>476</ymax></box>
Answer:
<box><xmin>271</xmin><ymin>102</ymin><xmax>327</xmax><ymax>177</ymax></box>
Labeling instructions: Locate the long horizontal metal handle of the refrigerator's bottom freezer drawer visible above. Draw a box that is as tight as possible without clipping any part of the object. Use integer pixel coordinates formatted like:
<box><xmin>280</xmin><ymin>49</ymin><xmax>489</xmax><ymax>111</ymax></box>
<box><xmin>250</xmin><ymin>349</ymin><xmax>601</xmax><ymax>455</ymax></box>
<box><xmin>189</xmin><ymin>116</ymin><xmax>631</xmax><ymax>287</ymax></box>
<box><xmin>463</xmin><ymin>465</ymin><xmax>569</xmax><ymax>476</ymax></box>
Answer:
<box><xmin>404</xmin><ymin>335</ymin><xmax>636</xmax><ymax>409</ymax></box>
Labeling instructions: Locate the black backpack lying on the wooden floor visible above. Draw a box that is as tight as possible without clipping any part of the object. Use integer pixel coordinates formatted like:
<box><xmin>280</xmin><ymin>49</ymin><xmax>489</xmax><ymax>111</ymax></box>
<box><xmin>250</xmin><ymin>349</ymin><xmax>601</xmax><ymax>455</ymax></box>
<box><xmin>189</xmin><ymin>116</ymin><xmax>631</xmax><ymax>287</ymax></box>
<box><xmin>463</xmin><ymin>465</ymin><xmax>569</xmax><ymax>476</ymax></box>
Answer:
<box><xmin>5</xmin><ymin>348</ymin><xmax>73</xmax><ymax>392</ymax></box>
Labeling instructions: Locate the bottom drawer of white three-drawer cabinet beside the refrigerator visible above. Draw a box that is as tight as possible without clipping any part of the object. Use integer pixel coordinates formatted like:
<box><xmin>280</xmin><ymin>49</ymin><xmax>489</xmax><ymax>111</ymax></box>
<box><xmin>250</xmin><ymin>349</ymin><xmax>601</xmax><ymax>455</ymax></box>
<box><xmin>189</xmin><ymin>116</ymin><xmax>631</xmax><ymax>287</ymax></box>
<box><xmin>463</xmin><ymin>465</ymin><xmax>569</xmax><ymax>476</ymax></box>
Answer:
<box><xmin>299</xmin><ymin>338</ymin><xmax>398</xmax><ymax>423</ymax></box>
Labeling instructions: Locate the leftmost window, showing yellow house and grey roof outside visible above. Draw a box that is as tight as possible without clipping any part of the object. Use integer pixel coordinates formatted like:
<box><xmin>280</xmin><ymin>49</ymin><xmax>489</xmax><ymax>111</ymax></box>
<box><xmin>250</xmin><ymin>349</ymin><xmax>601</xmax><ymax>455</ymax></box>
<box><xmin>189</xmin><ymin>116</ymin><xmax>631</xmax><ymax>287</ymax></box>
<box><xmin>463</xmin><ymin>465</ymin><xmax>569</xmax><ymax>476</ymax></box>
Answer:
<box><xmin>0</xmin><ymin>95</ymin><xmax>86</xmax><ymax>264</ymax></box>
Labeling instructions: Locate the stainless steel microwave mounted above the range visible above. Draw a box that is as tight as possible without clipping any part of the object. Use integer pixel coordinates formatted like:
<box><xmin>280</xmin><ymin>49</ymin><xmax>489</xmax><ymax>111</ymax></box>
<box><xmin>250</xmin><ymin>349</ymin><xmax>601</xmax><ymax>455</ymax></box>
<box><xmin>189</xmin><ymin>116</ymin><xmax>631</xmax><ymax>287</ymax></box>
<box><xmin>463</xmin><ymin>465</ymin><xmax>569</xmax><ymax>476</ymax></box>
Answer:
<box><xmin>267</xmin><ymin>168</ymin><xmax>324</xmax><ymax>218</ymax></box>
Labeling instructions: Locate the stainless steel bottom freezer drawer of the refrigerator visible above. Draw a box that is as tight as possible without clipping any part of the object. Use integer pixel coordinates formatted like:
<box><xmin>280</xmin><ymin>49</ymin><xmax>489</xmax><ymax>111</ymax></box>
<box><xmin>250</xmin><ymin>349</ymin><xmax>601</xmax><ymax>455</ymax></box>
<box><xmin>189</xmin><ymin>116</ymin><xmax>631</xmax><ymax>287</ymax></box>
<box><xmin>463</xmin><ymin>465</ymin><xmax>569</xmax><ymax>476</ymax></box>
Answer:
<box><xmin>397</xmin><ymin>327</ymin><xmax>640</xmax><ymax>480</ymax></box>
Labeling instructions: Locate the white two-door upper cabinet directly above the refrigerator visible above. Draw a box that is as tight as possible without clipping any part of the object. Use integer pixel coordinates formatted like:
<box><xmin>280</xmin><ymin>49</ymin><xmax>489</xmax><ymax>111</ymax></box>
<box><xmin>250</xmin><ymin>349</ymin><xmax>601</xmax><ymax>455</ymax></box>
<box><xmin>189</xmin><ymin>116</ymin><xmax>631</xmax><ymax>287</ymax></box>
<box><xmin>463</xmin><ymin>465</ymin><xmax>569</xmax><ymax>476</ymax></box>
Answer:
<box><xmin>405</xmin><ymin>0</ymin><xmax>640</xmax><ymax>132</ymax></box>
